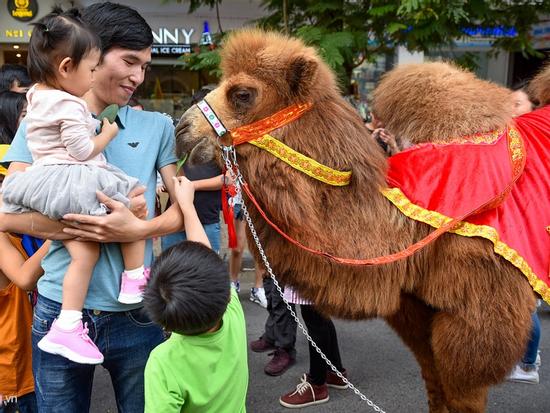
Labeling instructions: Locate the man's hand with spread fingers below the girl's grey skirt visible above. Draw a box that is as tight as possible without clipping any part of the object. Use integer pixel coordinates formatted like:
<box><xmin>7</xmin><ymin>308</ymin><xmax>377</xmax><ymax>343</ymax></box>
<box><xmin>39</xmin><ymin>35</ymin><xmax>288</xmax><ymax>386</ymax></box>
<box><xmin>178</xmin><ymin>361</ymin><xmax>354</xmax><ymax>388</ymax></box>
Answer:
<box><xmin>62</xmin><ymin>191</ymin><xmax>146</xmax><ymax>242</ymax></box>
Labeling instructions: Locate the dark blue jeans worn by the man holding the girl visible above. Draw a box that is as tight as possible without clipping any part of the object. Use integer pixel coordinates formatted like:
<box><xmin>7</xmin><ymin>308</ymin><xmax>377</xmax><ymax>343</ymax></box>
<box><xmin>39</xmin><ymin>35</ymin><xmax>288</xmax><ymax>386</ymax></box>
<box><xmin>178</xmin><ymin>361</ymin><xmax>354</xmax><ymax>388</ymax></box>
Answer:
<box><xmin>32</xmin><ymin>295</ymin><xmax>164</xmax><ymax>413</ymax></box>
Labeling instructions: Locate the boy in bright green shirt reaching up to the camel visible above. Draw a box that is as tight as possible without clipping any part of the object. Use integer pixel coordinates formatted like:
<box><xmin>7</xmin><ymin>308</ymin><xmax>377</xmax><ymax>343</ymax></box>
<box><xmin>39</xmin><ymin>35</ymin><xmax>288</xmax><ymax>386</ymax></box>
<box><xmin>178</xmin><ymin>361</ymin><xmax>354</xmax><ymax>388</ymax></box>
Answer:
<box><xmin>143</xmin><ymin>177</ymin><xmax>248</xmax><ymax>413</ymax></box>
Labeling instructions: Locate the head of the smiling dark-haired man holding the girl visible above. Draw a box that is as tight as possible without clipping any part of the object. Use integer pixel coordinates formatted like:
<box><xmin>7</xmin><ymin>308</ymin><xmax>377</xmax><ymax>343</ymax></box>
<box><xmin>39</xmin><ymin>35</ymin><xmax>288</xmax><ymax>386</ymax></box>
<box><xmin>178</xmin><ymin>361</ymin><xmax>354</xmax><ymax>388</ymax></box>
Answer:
<box><xmin>82</xmin><ymin>2</ymin><xmax>153</xmax><ymax>106</ymax></box>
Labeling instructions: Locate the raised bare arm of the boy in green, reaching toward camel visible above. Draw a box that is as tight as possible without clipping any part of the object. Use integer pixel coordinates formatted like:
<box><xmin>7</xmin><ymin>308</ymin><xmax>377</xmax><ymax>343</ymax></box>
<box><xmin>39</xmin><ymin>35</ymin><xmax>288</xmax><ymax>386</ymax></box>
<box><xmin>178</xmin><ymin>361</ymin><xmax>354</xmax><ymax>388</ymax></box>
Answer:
<box><xmin>173</xmin><ymin>176</ymin><xmax>211</xmax><ymax>248</ymax></box>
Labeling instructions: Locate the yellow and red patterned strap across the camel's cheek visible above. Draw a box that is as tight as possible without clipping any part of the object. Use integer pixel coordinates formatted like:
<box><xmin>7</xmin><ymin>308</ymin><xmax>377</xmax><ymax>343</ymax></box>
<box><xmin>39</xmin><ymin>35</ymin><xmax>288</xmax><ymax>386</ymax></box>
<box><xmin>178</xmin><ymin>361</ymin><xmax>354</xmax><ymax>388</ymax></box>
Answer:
<box><xmin>249</xmin><ymin>135</ymin><xmax>351</xmax><ymax>186</ymax></box>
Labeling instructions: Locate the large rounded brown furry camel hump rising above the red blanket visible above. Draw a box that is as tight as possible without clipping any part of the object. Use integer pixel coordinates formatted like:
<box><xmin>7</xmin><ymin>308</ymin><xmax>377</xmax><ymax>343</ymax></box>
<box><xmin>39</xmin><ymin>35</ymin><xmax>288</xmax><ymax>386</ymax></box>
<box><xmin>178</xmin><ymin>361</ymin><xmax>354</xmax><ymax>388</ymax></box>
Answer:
<box><xmin>373</xmin><ymin>62</ymin><xmax>513</xmax><ymax>143</ymax></box>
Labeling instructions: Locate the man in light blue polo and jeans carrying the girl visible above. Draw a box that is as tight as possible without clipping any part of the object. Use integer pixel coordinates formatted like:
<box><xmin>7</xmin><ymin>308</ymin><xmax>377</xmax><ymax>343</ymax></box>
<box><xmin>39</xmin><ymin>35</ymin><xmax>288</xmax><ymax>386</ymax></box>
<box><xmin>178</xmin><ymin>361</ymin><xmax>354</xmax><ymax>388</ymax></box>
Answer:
<box><xmin>0</xmin><ymin>3</ymin><xmax>182</xmax><ymax>413</ymax></box>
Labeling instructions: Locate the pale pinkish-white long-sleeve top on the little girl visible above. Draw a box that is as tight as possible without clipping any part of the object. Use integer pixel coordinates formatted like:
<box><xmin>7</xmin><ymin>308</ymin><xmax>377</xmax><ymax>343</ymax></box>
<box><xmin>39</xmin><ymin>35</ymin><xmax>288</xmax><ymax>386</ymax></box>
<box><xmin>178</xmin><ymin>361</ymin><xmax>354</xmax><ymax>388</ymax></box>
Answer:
<box><xmin>25</xmin><ymin>86</ymin><xmax>106</xmax><ymax>166</ymax></box>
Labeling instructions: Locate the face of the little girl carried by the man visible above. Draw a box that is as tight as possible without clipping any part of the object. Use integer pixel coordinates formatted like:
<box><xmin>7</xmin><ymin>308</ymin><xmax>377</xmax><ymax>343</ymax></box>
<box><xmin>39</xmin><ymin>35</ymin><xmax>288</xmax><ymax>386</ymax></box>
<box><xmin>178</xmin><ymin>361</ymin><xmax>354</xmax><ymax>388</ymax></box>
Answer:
<box><xmin>58</xmin><ymin>49</ymin><xmax>100</xmax><ymax>97</ymax></box>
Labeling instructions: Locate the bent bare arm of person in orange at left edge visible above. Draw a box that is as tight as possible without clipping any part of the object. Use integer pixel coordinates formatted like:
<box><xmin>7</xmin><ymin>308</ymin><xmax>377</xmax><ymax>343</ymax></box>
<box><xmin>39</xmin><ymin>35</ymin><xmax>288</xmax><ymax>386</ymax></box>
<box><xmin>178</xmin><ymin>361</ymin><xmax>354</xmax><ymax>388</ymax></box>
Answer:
<box><xmin>0</xmin><ymin>233</ymin><xmax>50</xmax><ymax>291</ymax></box>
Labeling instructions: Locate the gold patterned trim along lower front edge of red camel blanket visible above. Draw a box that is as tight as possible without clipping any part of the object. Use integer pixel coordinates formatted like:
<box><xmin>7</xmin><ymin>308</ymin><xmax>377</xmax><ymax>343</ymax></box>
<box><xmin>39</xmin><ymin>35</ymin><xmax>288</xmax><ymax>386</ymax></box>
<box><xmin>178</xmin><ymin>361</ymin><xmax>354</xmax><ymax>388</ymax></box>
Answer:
<box><xmin>381</xmin><ymin>188</ymin><xmax>550</xmax><ymax>304</ymax></box>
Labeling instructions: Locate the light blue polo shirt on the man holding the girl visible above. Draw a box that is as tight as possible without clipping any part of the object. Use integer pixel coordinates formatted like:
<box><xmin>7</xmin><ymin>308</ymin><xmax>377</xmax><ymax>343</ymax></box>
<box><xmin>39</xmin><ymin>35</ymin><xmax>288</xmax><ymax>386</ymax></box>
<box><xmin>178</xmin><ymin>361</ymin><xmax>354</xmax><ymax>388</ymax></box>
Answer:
<box><xmin>2</xmin><ymin>106</ymin><xmax>177</xmax><ymax>311</ymax></box>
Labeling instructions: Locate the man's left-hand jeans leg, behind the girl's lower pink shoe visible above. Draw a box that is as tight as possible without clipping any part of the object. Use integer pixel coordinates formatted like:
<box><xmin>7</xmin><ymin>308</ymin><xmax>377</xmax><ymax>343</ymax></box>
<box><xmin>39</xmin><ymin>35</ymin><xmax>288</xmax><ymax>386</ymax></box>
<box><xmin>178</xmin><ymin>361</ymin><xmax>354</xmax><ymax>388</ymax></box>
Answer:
<box><xmin>32</xmin><ymin>295</ymin><xmax>95</xmax><ymax>413</ymax></box>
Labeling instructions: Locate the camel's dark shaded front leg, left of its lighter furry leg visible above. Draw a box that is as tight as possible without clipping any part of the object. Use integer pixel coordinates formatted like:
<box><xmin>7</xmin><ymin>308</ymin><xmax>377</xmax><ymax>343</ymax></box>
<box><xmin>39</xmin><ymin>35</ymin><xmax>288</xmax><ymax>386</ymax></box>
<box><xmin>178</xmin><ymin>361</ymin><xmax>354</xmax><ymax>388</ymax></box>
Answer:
<box><xmin>386</xmin><ymin>294</ymin><xmax>448</xmax><ymax>413</ymax></box>
